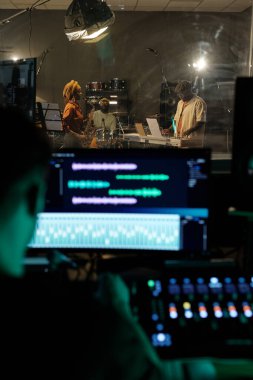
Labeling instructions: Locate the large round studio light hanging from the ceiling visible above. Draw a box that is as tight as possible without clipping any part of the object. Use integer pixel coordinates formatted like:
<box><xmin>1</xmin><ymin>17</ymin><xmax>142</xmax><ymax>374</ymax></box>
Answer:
<box><xmin>64</xmin><ymin>0</ymin><xmax>115</xmax><ymax>42</ymax></box>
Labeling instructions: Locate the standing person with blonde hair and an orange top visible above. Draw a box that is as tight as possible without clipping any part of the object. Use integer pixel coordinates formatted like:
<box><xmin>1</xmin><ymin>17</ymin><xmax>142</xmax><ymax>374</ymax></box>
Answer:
<box><xmin>62</xmin><ymin>79</ymin><xmax>85</xmax><ymax>148</ymax></box>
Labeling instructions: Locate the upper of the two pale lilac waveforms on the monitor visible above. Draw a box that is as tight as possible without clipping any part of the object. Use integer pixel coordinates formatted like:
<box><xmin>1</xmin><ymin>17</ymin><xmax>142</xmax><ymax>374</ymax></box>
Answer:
<box><xmin>72</xmin><ymin>162</ymin><xmax>137</xmax><ymax>171</ymax></box>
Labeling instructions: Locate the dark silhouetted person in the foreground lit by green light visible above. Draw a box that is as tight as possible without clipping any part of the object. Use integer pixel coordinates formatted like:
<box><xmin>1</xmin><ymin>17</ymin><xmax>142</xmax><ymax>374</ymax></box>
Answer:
<box><xmin>0</xmin><ymin>108</ymin><xmax>253</xmax><ymax>380</ymax></box>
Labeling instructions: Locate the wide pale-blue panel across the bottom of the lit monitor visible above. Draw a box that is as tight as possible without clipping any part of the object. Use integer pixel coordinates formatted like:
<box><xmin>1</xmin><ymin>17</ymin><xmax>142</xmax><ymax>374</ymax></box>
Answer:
<box><xmin>30</xmin><ymin>213</ymin><xmax>180</xmax><ymax>251</ymax></box>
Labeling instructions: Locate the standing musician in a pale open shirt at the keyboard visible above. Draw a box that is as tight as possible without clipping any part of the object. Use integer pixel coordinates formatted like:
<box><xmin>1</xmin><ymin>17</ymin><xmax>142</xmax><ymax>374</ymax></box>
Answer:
<box><xmin>174</xmin><ymin>80</ymin><xmax>207</xmax><ymax>139</ymax></box>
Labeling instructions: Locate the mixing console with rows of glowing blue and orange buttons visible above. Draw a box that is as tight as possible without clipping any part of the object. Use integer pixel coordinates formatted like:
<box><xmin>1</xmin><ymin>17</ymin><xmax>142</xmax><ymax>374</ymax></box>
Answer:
<box><xmin>125</xmin><ymin>274</ymin><xmax>253</xmax><ymax>358</ymax></box>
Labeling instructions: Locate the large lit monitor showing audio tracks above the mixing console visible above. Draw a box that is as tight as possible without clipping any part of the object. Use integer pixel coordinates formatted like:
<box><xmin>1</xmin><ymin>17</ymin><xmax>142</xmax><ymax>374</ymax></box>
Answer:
<box><xmin>28</xmin><ymin>148</ymin><xmax>210</xmax><ymax>254</ymax></box>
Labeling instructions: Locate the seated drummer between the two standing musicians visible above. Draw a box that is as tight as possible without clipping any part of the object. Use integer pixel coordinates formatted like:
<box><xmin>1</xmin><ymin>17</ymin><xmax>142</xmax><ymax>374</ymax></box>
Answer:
<box><xmin>90</xmin><ymin>98</ymin><xmax>117</xmax><ymax>148</ymax></box>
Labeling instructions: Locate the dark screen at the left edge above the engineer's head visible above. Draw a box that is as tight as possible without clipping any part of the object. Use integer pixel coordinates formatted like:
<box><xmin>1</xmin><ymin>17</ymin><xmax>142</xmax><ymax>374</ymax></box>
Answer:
<box><xmin>0</xmin><ymin>58</ymin><xmax>36</xmax><ymax>120</ymax></box>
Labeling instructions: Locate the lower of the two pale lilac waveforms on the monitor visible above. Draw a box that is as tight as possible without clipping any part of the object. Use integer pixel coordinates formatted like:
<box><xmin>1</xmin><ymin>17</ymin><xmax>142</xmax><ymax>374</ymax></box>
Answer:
<box><xmin>72</xmin><ymin>197</ymin><xmax>137</xmax><ymax>206</ymax></box>
